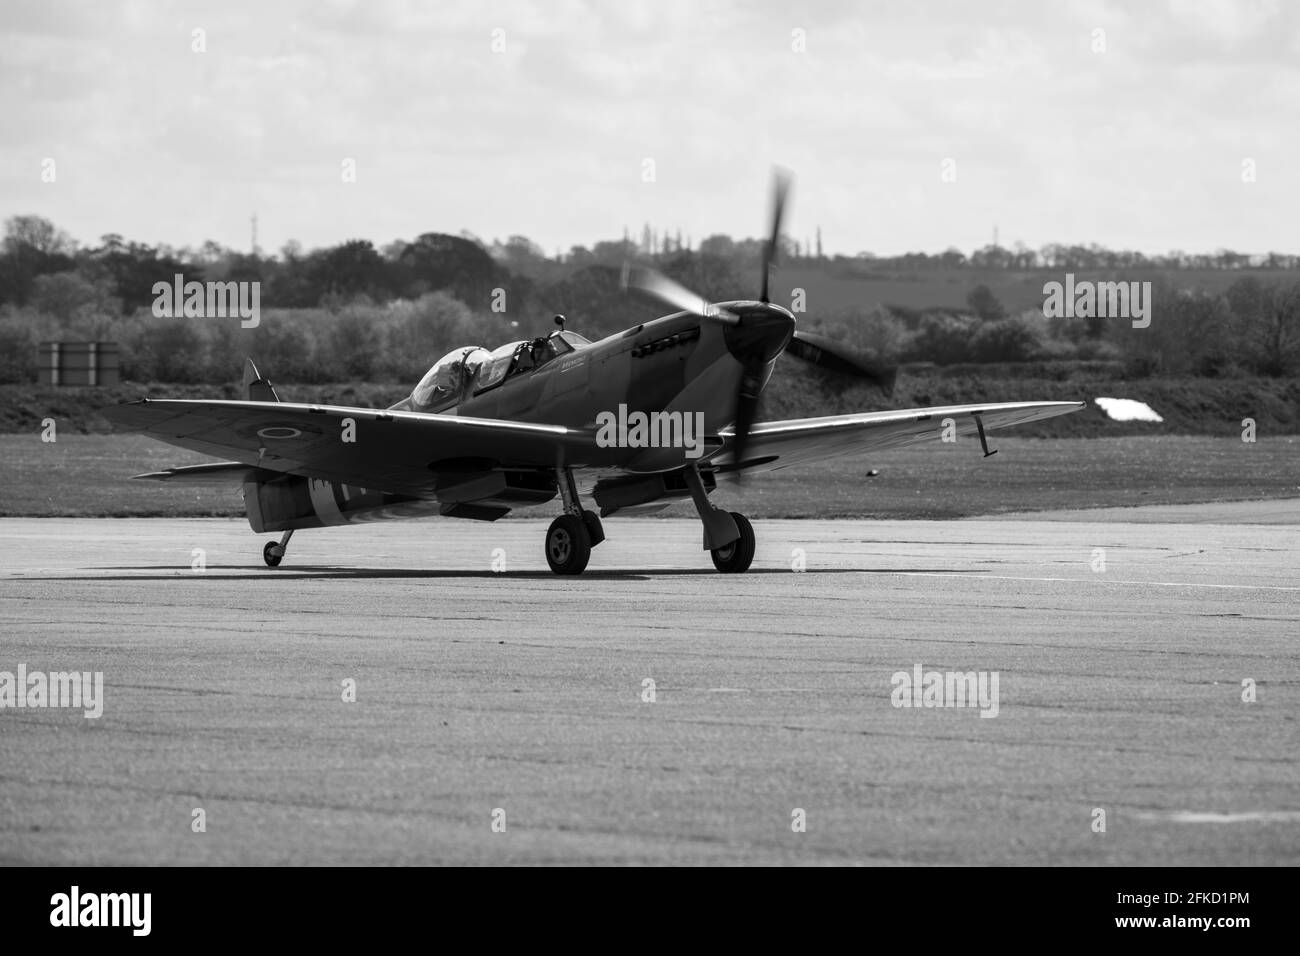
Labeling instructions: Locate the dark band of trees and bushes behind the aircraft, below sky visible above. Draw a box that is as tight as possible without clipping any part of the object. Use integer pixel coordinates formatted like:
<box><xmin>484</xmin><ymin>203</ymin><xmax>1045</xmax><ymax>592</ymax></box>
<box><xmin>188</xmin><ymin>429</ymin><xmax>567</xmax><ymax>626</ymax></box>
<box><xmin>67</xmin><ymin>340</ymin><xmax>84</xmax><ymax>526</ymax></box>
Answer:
<box><xmin>0</xmin><ymin>216</ymin><xmax>1300</xmax><ymax>382</ymax></box>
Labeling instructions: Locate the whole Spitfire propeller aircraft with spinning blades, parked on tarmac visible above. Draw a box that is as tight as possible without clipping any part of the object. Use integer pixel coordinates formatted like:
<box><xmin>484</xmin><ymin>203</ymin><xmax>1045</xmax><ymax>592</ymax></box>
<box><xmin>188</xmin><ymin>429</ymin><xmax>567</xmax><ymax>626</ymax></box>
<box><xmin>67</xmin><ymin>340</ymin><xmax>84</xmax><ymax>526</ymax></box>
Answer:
<box><xmin>105</xmin><ymin>174</ymin><xmax>1083</xmax><ymax>575</ymax></box>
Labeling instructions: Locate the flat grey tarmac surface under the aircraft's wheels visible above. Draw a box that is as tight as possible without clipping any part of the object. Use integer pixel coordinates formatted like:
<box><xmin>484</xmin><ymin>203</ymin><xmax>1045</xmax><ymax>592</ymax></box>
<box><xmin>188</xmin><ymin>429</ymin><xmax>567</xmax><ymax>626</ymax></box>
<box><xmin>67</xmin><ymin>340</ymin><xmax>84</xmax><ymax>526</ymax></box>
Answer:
<box><xmin>0</xmin><ymin>502</ymin><xmax>1300</xmax><ymax>868</ymax></box>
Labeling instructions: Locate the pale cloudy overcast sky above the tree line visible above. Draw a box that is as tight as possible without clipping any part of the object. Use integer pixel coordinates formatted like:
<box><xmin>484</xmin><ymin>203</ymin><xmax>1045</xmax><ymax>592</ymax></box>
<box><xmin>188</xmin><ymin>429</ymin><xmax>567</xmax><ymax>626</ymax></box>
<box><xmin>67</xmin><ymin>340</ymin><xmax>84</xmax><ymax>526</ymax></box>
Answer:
<box><xmin>0</xmin><ymin>0</ymin><xmax>1300</xmax><ymax>254</ymax></box>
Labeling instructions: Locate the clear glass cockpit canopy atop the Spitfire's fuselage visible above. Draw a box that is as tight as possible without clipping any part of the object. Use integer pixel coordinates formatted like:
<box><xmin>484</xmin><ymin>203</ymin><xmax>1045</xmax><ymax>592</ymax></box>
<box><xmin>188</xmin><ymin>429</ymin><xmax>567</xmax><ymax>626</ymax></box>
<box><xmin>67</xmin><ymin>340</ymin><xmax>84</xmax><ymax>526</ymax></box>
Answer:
<box><xmin>411</xmin><ymin>332</ymin><xmax>590</xmax><ymax>412</ymax></box>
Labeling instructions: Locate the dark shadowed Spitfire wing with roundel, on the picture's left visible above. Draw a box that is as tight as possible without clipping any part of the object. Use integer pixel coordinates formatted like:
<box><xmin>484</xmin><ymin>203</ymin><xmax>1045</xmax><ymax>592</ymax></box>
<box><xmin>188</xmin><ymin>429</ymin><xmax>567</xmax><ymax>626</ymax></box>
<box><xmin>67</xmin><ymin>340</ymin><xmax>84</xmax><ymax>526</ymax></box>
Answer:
<box><xmin>103</xmin><ymin>399</ymin><xmax>619</xmax><ymax>496</ymax></box>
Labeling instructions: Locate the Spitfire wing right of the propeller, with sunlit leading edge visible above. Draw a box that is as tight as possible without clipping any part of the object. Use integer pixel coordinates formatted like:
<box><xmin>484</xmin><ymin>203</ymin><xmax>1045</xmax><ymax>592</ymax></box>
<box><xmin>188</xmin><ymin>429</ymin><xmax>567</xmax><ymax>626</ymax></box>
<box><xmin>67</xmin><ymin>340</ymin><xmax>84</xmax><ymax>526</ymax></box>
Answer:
<box><xmin>711</xmin><ymin>402</ymin><xmax>1087</xmax><ymax>475</ymax></box>
